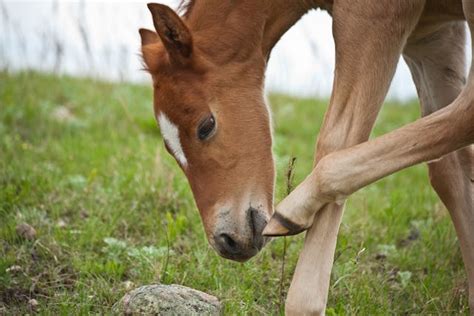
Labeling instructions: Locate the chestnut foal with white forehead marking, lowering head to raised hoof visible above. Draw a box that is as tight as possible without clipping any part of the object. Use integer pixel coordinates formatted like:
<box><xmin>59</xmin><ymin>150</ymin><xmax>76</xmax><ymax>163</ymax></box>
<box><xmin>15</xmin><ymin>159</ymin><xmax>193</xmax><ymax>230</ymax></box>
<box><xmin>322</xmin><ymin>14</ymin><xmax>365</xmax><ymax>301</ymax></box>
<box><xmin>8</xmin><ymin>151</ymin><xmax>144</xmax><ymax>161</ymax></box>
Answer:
<box><xmin>140</xmin><ymin>0</ymin><xmax>474</xmax><ymax>314</ymax></box>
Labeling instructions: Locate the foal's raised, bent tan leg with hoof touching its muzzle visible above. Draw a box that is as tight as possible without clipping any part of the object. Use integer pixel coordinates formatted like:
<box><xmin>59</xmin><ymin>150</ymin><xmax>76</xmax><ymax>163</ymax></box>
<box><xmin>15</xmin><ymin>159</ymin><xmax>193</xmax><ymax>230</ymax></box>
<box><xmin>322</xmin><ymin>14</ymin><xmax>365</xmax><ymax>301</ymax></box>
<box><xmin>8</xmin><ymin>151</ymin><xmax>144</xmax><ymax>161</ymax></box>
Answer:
<box><xmin>264</xmin><ymin>59</ymin><xmax>474</xmax><ymax>235</ymax></box>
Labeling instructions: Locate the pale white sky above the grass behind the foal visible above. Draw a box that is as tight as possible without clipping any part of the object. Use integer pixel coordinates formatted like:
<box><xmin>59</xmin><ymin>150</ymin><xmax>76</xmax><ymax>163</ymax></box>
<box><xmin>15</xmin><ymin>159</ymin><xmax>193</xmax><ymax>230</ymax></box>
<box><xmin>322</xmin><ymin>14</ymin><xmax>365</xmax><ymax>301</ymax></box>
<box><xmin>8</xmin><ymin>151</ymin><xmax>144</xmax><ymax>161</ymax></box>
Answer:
<box><xmin>0</xmin><ymin>0</ymin><xmax>470</xmax><ymax>100</ymax></box>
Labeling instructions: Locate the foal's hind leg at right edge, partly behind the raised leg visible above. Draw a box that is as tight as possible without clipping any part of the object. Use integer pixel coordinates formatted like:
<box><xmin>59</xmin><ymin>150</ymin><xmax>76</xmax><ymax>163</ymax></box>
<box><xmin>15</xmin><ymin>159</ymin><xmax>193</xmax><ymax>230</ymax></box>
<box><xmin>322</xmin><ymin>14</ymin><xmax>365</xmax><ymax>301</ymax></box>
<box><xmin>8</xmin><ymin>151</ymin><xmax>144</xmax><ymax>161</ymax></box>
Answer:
<box><xmin>404</xmin><ymin>22</ymin><xmax>474</xmax><ymax>313</ymax></box>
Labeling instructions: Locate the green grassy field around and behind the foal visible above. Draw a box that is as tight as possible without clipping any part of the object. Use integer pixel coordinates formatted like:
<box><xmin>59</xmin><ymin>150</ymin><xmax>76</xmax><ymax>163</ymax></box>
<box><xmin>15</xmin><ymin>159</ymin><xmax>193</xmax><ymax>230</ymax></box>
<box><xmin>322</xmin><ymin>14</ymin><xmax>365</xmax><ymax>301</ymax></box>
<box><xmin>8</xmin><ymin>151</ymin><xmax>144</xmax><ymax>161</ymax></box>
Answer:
<box><xmin>0</xmin><ymin>73</ymin><xmax>468</xmax><ymax>315</ymax></box>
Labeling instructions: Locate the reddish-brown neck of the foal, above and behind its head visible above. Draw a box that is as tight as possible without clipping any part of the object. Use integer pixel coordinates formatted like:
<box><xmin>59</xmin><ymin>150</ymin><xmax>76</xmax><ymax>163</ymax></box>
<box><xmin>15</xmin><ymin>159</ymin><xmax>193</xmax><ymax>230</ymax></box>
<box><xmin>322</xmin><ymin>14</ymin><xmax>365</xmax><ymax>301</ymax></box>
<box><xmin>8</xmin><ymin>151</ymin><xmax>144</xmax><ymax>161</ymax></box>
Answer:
<box><xmin>186</xmin><ymin>0</ymin><xmax>322</xmax><ymax>64</ymax></box>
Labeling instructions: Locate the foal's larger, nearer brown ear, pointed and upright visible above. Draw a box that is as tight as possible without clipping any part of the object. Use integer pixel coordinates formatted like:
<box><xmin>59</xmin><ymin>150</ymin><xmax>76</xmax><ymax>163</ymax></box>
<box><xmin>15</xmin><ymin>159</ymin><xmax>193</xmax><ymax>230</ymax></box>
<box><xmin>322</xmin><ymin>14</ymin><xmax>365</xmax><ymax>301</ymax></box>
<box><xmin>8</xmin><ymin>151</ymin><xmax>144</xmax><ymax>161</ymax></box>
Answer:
<box><xmin>147</xmin><ymin>3</ymin><xmax>193</xmax><ymax>65</ymax></box>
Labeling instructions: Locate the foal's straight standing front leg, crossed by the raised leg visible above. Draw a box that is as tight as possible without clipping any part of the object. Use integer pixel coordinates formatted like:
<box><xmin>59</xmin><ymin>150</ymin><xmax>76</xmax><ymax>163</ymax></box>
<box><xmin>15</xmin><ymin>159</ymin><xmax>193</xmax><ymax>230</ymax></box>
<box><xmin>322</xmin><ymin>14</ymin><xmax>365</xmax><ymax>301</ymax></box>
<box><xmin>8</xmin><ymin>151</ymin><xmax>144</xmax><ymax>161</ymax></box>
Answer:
<box><xmin>280</xmin><ymin>0</ymin><xmax>421</xmax><ymax>315</ymax></box>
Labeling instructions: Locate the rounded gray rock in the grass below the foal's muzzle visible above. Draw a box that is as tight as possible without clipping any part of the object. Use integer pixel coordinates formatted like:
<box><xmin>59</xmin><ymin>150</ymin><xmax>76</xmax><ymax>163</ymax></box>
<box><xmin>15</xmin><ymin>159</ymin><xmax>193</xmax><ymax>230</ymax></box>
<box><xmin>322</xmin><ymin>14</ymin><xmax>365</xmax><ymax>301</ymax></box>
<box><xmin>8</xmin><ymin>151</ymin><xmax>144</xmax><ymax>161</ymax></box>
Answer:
<box><xmin>113</xmin><ymin>284</ymin><xmax>221</xmax><ymax>315</ymax></box>
